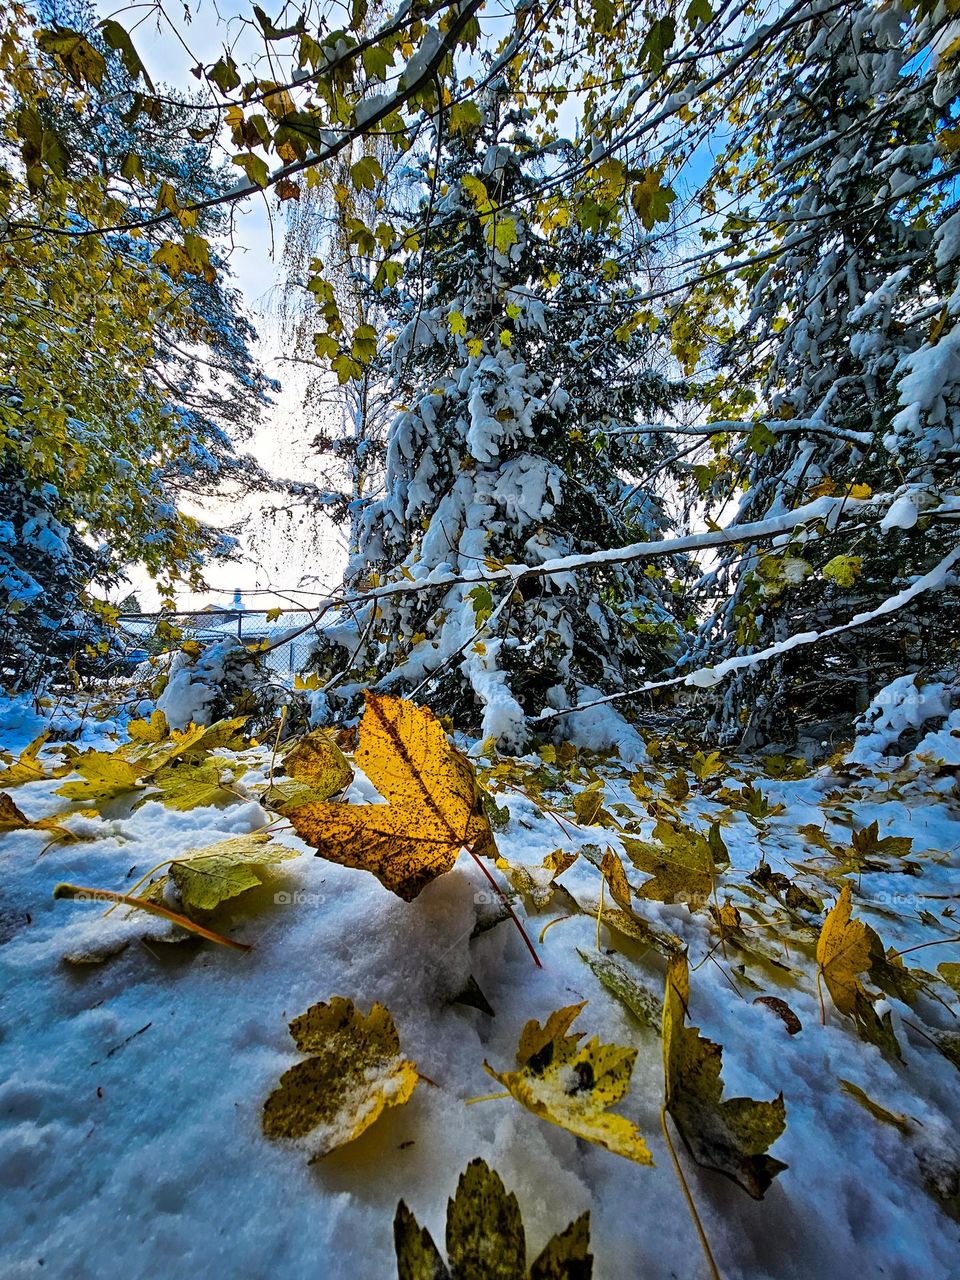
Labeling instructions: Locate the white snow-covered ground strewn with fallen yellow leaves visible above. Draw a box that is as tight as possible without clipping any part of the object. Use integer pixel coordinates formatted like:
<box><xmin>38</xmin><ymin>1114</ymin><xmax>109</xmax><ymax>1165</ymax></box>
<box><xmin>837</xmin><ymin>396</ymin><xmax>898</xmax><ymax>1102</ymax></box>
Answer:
<box><xmin>0</xmin><ymin>701</ymin><xmax>960</xmax><ymax>1280</ymax></box>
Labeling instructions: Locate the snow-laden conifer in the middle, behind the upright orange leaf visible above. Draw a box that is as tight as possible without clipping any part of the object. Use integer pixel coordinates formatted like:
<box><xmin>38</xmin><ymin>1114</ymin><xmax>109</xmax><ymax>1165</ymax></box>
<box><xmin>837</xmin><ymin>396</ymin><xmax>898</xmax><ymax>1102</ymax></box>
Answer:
<box><xmin>330</xmin><ymin>104</ymin><xmax>677</xmax><ymax>749</ymax></box>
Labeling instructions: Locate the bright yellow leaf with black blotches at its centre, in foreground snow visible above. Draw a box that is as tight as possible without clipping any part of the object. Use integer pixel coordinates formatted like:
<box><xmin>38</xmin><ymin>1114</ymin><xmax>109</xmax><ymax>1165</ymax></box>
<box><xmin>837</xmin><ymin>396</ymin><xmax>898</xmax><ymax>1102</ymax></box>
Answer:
<box><xmin>484</xmin><ymin>1001</ymin><xmax>653</xmax><ymax>1165</ymax></box>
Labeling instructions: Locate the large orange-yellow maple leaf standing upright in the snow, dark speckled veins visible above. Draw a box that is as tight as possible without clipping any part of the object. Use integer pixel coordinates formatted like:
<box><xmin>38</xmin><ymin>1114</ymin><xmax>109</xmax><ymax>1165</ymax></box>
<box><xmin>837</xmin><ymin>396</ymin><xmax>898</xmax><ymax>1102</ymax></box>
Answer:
<box><xmin>289</xmin><ymin>692</ymin><xmax>493</xmax><ymax>902</ymax></box>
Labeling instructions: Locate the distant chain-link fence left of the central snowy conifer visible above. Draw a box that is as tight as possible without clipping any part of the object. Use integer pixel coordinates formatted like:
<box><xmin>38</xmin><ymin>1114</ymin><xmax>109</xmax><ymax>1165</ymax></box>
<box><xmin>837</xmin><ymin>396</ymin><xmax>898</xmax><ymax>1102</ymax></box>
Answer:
<box><xmin>118</xmin><ymin>609</ymin><xmax>316</xmax><ymax>675</ymax></box>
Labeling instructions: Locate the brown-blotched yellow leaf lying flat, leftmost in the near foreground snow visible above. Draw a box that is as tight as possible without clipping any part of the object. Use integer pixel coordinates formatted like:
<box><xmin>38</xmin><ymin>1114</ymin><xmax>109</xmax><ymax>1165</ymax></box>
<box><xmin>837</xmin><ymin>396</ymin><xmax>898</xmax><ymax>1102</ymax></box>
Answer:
<box><xmin>262</xmin><ymin>996</ymin><xmax>419</xmax><ymax>1160</ymax></box>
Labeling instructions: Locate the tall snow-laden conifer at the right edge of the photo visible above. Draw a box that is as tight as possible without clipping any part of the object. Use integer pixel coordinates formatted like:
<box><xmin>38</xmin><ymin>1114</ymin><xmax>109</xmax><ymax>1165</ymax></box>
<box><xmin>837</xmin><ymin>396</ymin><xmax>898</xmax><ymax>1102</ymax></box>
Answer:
<box><xmin>694</xmin><ymin>0</ymin><xmax>960</xmax><ymax>745</ymax></box>
